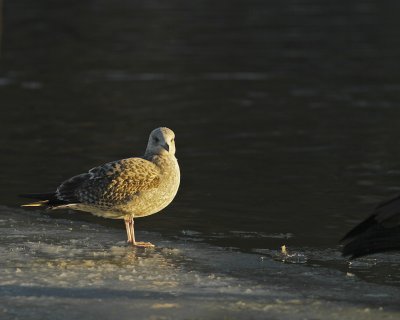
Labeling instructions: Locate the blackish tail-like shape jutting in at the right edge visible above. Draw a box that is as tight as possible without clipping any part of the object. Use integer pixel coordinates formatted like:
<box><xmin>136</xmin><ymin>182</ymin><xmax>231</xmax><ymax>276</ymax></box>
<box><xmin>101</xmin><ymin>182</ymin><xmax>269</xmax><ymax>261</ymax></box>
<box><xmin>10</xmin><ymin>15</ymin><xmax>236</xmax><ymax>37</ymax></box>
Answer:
<box><xmin>341</xmin><ymin>196</ymin><xmax>400</xmax><ymax>259</ymax></box>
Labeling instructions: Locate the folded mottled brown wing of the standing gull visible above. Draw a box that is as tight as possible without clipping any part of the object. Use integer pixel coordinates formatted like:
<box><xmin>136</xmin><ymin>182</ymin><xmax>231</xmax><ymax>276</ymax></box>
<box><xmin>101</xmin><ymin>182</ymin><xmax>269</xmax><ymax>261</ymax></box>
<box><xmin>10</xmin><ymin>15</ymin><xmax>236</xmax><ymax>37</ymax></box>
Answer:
<box><xmin>56</xmin><ymin>158</ymin><xmax>160</xmax><ymax>207</ymax></box>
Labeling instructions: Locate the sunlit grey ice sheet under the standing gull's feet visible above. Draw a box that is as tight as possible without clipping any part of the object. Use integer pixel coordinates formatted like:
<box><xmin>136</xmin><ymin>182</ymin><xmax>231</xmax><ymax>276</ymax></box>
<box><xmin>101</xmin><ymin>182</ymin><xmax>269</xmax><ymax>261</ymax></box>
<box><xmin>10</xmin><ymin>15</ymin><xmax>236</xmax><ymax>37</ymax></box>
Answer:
<box><xmin>0</xmin><ymin>207</ymin><xmax>400</xmax><ymax>320</ymax></box>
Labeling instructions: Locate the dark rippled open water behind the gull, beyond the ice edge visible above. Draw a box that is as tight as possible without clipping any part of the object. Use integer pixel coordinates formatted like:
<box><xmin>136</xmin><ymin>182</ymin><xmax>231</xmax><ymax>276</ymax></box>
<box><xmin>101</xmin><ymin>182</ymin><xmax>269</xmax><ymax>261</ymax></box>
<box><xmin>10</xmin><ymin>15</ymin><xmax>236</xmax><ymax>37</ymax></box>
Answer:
<box><xmin>0</xmin><ymin>0</ymin><xmax>400</xmax><ymax>304</ymax></box>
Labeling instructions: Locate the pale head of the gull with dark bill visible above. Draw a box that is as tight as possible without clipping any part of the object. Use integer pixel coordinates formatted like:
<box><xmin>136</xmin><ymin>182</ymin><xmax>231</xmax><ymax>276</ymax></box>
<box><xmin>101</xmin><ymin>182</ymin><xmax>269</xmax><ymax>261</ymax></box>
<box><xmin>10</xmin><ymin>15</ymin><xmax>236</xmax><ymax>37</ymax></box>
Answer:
<box><xmin>146</xmin><ymin>127</ymin><xmax>176</xmax><ymax>155</ymax></box>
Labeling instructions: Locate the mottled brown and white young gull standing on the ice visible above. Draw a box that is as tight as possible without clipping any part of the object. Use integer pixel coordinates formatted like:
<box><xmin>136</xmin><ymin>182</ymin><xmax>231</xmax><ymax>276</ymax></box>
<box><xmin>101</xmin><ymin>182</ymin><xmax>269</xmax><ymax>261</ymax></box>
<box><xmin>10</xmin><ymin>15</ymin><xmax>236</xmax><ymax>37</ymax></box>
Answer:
<box><xmin>21</xmin><ymin>127</ymin><xmax>180</xmax><ymax>247</ymax></box>
